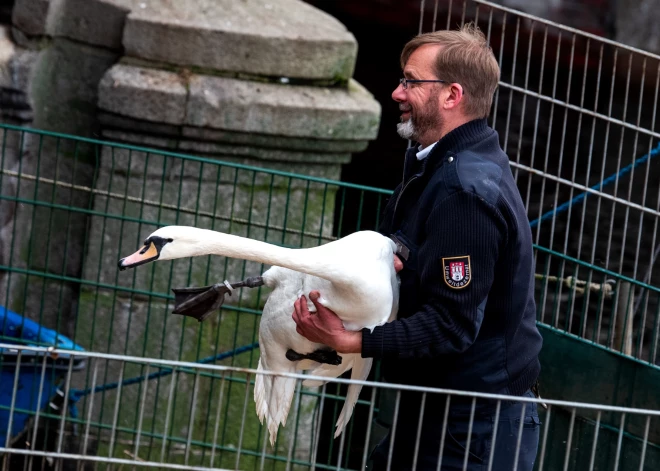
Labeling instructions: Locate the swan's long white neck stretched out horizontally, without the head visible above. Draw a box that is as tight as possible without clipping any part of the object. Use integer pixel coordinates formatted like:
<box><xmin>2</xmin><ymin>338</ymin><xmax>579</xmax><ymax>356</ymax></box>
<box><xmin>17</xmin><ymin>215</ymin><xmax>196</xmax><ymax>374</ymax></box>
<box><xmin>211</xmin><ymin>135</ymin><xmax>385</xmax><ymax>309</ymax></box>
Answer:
<box><xmin>172</xmin><ymin>227</ymin><xmax>332</xmax><ymax>278</ymax></box>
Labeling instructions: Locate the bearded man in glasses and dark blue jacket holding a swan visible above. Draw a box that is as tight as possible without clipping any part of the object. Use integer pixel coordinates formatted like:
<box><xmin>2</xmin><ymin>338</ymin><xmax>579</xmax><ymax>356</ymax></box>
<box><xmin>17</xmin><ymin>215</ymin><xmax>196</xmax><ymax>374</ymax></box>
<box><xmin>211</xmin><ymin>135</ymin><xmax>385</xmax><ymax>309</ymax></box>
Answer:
<box><xmin>293</xmin><ymin>25</ymin><xmax>542</xmax><ymax>471</ymax></box>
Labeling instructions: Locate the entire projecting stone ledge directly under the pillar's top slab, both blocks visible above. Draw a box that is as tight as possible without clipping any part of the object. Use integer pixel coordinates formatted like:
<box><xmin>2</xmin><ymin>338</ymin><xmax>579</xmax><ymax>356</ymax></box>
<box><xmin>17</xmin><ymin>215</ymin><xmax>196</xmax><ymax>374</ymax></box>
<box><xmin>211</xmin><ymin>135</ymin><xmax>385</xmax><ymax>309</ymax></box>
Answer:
<box><xmin>99</xmin><ymin>64</ymin><xmax>380</xmax><ymax>140</ymax></box>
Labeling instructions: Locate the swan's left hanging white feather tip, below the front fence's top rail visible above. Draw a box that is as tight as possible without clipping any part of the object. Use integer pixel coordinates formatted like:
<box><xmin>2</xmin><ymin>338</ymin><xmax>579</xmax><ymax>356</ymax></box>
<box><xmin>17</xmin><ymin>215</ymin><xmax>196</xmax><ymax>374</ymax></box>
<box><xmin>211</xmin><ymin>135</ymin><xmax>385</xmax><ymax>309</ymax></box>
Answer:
<box><xmin>254</xmin><ymin>358</ymin><xmax>296</xmax><ymax>446</ymax></box>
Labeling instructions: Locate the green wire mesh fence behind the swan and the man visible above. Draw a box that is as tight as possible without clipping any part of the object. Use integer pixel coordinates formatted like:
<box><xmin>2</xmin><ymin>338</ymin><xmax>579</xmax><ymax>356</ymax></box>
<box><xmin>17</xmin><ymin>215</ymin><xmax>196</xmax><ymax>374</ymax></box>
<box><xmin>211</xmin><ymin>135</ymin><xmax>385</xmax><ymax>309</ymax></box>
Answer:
<box><xmin>0</xmin><ymin>120</ymin><xmax>660</xmax><ymax>469</ymax></box>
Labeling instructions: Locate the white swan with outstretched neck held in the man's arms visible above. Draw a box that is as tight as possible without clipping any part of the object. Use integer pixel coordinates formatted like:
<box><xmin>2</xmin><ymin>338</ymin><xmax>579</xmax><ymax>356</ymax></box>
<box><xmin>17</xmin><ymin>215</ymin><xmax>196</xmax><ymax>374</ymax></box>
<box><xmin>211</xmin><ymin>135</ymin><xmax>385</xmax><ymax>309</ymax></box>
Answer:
<box><xmin>119</xmin><ymin>226</ymin><xmax>399</xmax><ymax>445</ymax></box>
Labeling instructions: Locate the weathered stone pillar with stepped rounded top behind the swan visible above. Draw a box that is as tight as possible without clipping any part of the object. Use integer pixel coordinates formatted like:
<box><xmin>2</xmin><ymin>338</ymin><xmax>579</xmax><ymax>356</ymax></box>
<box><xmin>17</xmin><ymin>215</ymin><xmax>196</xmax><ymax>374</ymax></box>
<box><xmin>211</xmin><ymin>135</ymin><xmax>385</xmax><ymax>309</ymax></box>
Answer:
<box><xmin>80</xmin><ymin>0</ymin><xmax>380</xmax><ymax>458</ymax></box>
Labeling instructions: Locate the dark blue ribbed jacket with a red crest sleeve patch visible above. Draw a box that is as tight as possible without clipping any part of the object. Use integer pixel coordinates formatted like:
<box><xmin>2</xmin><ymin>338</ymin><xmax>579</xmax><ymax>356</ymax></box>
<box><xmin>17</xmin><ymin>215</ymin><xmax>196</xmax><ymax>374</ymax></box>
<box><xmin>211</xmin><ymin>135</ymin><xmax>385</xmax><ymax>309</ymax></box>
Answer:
<box><xmin>362</xmin><ymin>119</ymin><xmax>542</xmax><ymax>395</ymax></box>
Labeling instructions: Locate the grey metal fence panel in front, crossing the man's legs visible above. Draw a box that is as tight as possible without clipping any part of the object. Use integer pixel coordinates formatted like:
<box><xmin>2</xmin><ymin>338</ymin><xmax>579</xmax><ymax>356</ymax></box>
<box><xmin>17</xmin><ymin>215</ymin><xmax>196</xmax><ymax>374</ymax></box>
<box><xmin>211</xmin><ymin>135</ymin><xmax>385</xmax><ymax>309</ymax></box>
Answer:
<box><xmin>0</xmin><ymin>344</ymin><xmax>660</xmax><ymax>470</ymax></box>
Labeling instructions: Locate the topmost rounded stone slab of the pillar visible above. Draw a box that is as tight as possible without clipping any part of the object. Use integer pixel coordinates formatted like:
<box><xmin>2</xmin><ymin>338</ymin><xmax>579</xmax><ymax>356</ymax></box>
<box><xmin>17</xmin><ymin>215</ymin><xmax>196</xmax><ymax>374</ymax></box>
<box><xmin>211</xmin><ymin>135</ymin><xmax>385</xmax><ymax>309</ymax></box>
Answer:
<box><xmin>123</xmin><ymin>0</ymin><xmax>357</xmax><ymax>80</ymax></box>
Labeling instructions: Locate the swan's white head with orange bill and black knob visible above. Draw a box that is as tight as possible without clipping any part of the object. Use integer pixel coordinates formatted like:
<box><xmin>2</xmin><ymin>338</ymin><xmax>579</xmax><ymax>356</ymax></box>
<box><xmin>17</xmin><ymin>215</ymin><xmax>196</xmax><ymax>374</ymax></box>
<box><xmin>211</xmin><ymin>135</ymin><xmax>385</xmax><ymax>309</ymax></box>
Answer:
<box><xmin>119</xmin><ymin>226</ymin><xmax>209</xmax><ymax>270</ymax></box>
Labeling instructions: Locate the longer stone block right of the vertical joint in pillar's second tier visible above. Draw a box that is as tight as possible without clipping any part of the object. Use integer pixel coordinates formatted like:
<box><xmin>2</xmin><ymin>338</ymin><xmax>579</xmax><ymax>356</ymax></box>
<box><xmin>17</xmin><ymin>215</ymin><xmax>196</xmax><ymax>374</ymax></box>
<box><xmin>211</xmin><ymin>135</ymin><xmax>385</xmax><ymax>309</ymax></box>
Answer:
<box><xmin>186</xmin><ymin>75</ymin><xmax>380</xmax><ymax>140</ymax></box>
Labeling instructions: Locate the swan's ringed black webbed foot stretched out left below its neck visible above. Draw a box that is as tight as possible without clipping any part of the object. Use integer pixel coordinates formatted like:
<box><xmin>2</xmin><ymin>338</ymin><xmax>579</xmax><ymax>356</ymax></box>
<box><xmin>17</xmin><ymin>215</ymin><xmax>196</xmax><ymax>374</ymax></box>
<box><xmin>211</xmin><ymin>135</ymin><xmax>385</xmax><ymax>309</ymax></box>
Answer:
<box><xmin>172</xmin><ymin>276</ymin><xmax>264</xmax><ymax>322</ymax></box>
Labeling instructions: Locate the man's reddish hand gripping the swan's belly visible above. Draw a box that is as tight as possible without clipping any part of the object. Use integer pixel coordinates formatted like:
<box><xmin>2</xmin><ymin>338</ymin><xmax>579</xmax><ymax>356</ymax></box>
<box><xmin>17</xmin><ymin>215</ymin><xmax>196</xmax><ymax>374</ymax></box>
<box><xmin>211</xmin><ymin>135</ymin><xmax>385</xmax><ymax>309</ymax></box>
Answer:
<box><xmin>293</xmin><ymin>291</ymin><xmax>362</xmax><ymax>353</ymax></box>
